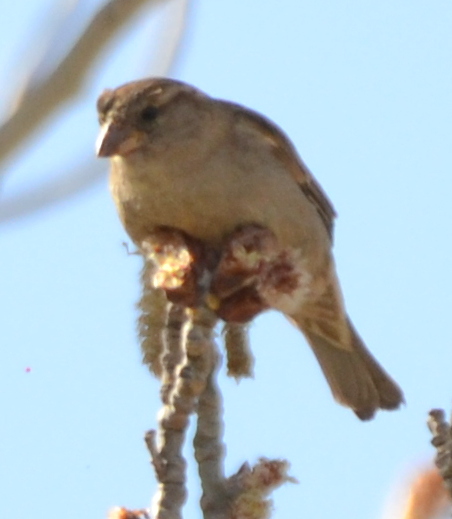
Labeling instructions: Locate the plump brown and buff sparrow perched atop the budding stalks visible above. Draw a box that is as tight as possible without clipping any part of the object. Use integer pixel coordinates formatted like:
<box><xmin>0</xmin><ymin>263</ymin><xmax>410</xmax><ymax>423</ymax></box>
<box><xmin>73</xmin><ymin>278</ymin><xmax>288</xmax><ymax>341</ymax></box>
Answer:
<box><xmin>97</xmin><ymin>78</ymin><xmax>403</xmax><ymax>420</ymax></box>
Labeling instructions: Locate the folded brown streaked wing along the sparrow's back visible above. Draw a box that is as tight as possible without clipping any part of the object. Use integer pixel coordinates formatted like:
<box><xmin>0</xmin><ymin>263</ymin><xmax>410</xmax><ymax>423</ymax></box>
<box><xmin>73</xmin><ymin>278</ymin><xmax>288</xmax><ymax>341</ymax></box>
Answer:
<box><xmin>230</xmin><ymin>102</ymin><xmax>336</xmax><ymax>240</ymax></box>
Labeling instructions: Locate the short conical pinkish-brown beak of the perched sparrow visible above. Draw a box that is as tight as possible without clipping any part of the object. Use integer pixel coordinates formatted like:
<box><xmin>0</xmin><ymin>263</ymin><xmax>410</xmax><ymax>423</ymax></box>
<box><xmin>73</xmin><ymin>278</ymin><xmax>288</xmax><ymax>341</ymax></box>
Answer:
<box><xmin>96</xmin><ymin>121</ymin><xmax>141</xmax><ymax>157</ymax></box>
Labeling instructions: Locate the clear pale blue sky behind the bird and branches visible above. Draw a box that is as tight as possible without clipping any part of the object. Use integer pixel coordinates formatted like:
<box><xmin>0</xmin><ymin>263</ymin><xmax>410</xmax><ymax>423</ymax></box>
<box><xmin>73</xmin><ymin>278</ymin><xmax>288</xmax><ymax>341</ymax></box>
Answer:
<box><xmin>0</xmin><ymin>0</ymin><xmax>452</xmax><ymax>519</ymax></box>
